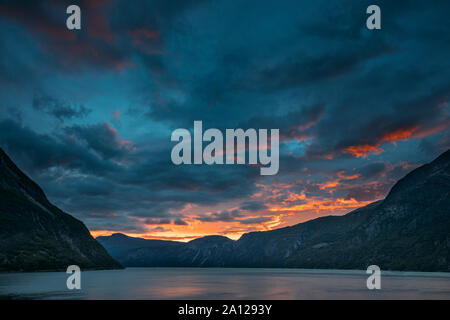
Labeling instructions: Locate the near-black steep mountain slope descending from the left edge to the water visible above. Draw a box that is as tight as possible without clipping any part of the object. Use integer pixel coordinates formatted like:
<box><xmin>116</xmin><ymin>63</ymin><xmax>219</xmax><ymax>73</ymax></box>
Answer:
<box><xmin>0</xmin><ymin>148</ymin><xmax>122</xmax><ymax>271</ymax></box>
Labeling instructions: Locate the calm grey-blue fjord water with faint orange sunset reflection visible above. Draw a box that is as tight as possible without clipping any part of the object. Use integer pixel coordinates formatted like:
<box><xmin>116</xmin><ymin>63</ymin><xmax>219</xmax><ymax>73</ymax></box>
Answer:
<box><xmin>0</xmin><ymin>268</ymin><xmax>450</xmax><ymax>300</ymax></box>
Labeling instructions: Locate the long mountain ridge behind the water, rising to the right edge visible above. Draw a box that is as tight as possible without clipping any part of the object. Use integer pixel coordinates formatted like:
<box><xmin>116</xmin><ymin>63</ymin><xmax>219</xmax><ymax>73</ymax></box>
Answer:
<box><xmin>98</xmin><ymin>150</ymin><xmax>450</xmax><ymax>271</ymax></box>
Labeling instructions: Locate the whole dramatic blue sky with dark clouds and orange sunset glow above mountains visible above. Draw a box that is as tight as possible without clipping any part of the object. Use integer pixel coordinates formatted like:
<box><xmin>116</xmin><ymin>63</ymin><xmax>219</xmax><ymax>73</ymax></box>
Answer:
<box><xmin>0</xmin><ymin>0</ymin><xmax>450</xmax><ymax>240</ymax></box>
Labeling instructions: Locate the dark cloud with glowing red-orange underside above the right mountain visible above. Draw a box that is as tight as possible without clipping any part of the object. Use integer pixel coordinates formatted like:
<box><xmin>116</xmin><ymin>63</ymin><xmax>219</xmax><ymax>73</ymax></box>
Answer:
<box><xmin>307</xmin><ymin>88</ymin><xmax>450</xmax><ymax>156</ymax></box>
